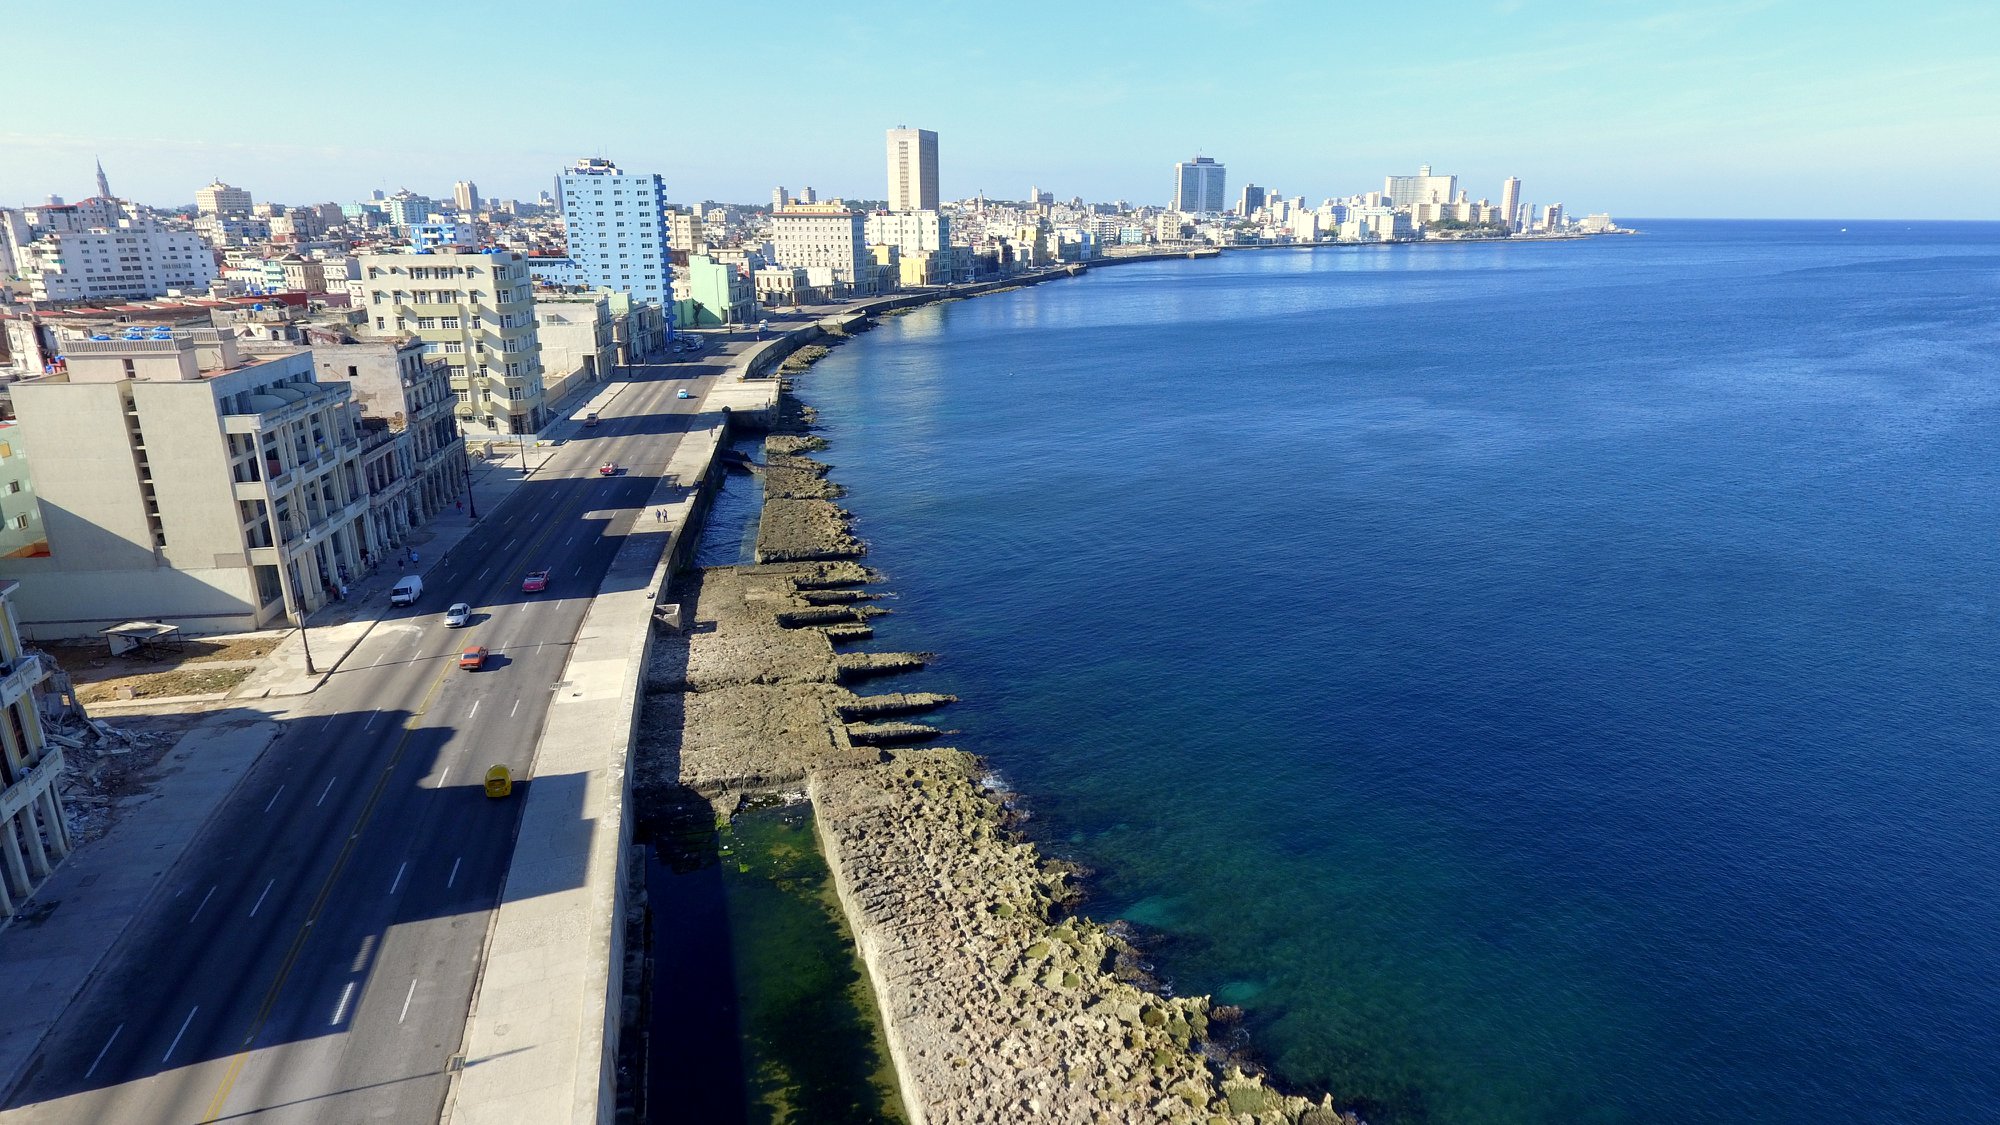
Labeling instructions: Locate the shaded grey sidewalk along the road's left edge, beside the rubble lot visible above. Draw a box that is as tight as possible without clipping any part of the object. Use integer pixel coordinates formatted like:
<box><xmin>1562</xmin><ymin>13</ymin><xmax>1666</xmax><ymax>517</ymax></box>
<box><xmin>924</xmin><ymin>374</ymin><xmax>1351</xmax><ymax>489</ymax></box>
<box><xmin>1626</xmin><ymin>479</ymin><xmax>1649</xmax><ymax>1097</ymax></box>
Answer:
<box><xmin>0</xmin><ymin>709</ymin><xmax>280</xmax><ymax>1103</ymax></box>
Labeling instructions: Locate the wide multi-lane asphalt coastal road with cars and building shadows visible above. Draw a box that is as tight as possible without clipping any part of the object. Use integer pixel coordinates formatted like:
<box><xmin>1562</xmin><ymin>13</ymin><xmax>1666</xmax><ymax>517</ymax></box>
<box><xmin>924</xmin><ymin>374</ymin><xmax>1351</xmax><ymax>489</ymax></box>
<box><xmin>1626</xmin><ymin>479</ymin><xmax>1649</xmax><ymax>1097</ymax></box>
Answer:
<box><xmin>0</xmin><ymin>344</ymin><xmax>740</xmax><ymax>1125</ymax></box>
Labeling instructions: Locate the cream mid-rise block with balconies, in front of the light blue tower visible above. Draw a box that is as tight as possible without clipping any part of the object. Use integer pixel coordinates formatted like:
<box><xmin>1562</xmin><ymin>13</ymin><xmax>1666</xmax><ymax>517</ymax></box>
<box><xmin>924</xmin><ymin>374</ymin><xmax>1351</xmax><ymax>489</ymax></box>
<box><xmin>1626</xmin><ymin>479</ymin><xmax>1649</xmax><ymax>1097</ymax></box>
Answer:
<box><xmin>360</xmin><ymin>250</ymin><xmax>548</xmax><ymax>434</ymax></box>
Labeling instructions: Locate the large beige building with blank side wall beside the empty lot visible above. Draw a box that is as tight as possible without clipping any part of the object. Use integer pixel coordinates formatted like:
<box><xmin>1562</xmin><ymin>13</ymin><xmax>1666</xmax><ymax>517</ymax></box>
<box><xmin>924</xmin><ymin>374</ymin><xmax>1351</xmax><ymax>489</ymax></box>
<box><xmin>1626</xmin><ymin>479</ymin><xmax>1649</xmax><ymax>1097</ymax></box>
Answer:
<box><xmin>0</xmin><ymin>328</ymin><xmax>368</xmax><ymax>637</ymax></box>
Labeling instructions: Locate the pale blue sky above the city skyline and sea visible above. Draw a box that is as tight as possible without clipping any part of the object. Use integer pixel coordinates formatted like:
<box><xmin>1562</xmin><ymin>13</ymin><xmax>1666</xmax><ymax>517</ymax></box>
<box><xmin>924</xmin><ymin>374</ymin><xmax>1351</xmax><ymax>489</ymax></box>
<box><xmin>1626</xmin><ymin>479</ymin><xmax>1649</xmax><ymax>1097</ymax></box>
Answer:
<box><xmin>0</xmin><ymin>0</ymin><xmax>2000</xmax><ymax>218</ymax></box>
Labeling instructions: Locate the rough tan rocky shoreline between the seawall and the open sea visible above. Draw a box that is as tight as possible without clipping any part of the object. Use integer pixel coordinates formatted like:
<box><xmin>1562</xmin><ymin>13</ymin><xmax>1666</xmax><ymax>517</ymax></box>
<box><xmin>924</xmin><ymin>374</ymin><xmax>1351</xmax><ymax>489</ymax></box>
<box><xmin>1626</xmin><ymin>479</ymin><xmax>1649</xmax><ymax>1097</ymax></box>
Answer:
<box><xmin>638</xmin><ymin>340</ymin><xmax>1356</xmax><ymax>1125</ymax></box>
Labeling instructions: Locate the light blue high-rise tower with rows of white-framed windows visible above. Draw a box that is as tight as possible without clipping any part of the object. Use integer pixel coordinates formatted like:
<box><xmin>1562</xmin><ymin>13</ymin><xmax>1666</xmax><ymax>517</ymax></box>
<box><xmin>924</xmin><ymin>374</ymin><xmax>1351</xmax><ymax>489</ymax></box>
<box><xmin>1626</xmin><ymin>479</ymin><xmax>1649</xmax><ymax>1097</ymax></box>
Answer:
<box><xmin>558</xmin><ymin>156</ymin><xmax>674</xmax><ymax>306</ymax></box>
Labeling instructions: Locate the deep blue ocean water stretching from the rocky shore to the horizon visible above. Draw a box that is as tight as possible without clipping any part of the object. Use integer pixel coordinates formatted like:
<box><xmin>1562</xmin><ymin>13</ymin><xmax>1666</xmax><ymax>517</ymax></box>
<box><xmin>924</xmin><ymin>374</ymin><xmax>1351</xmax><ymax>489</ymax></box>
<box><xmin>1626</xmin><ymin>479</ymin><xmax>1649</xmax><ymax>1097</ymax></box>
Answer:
<box><xmin>776</xmin><ymin>222</ymin><xmax>2000</xmax><ymax>1125</ymax></box>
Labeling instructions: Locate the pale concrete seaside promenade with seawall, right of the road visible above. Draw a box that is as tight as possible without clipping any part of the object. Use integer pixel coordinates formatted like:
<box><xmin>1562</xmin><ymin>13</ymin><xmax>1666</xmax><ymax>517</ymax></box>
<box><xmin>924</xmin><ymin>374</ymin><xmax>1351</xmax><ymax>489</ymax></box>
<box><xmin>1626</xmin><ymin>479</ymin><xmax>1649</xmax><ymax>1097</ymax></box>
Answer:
<box><xmin>444</xmin><ymin>366</ymin><xmax>776</xmax><ymax>1125</ymax></box>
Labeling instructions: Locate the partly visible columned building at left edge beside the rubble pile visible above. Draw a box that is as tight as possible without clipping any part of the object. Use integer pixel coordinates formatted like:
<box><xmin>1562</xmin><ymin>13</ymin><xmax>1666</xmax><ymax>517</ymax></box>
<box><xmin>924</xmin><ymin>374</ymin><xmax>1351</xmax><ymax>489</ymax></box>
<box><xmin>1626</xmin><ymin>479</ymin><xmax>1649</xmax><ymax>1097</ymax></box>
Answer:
<box><xmin>0</xmin><ymin>576</ymin><xmax>66</xmax><ymax>923</ymax></box>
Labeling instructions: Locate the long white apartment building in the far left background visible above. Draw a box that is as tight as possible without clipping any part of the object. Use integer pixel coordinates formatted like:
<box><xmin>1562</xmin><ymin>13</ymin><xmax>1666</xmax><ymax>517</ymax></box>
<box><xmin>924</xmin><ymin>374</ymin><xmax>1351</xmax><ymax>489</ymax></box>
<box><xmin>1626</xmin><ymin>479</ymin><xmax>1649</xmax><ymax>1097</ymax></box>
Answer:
<box><xmin>16</xmin><ymin>218</ymin><xmax>216</xmax><ymax>300</ymax></box>
